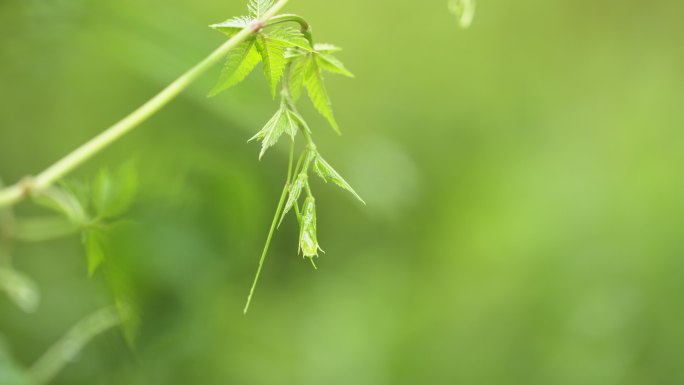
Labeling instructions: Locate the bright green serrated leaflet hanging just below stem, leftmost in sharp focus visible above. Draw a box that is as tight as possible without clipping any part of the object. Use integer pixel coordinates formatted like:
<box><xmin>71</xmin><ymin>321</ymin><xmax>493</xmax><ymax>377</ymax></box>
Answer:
<box><xmin>209</xmin><ymin>38</ymin><xmax>261</xmax><ymax>97</ymax></box>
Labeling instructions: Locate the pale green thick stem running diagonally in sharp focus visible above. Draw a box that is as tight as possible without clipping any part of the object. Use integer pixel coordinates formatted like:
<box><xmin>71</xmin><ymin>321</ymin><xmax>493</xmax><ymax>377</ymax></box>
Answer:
<box><xmin>0</xmin><ymin>0</ymin><xmax>289</xmax><ymax>207</ymax></box>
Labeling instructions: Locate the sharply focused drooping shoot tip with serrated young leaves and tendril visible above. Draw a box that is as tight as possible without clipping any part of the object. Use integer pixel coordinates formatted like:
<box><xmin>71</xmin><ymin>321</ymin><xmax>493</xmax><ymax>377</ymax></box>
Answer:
<box><xmin>210</xmin><ymin>0</ymin><xmax>363</xmax><ymax>311</ymax></box>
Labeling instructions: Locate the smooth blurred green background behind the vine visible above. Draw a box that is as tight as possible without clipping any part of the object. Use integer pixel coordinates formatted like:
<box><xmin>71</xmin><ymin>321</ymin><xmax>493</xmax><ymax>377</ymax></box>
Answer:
<box><xmin>0</xmin><ymin>0</ymin><xmax>684</xmax><ymax>385</ymax></box>
